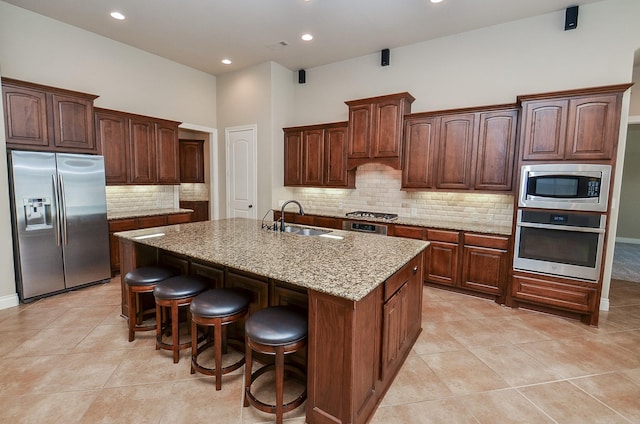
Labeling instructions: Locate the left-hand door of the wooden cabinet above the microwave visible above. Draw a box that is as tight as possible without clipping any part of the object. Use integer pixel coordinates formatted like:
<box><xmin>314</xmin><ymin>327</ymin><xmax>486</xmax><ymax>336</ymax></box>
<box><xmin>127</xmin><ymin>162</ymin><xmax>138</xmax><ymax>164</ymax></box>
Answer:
<box><xmin>522</xmin><ymin>100</ymin><xmax>568</xmax><ymax>160</ymax></box>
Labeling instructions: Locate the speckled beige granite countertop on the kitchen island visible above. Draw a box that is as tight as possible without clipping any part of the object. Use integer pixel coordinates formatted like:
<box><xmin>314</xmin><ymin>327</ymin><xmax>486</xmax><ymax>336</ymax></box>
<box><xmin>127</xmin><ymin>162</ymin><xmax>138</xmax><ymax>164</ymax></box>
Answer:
<box><xmin>115</xmin><ymin>218</ymin><xmax>429</xmax><ymax>301</ymax></box>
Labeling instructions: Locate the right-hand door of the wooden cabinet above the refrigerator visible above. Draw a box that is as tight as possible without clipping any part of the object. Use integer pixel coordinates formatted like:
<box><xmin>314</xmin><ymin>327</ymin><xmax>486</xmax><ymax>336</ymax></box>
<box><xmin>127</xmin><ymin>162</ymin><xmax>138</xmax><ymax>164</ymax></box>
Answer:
<box><xmin>51</xmin><ymin>93</ymin><xmax>97</xmax><ymax>153</ymax></box>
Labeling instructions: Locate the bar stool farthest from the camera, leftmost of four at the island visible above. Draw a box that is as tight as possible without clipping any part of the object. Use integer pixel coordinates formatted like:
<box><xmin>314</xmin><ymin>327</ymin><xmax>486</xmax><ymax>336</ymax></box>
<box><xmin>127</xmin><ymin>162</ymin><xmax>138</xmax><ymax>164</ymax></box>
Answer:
<box><xmin>124</xmin><ymin>266</ymin><xmax>178</xmax><ymax>342</ymax></box>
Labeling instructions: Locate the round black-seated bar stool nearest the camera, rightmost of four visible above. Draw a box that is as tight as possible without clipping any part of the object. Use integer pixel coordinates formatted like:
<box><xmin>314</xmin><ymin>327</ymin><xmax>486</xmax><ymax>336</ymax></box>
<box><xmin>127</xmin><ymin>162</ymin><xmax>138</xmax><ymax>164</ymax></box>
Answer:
<box><xmin>244</xmin><ymin>306</ymin><xmax>307</xmax><ymax>424</ymax></box>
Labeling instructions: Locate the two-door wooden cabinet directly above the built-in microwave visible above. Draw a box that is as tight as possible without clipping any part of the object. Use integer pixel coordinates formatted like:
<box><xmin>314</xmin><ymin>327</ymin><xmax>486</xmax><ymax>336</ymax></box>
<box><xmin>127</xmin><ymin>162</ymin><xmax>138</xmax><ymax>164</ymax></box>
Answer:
<box><xmin>518</xmin><ymin>84</ymin><xmax>630</xmax><ymax>161</ymax></box>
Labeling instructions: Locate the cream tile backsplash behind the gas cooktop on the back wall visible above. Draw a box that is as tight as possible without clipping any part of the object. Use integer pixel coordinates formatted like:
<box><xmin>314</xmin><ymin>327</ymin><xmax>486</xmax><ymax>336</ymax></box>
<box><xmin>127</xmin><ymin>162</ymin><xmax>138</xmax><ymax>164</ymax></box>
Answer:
<box><xmin>279</xmin><ymin>164</ymin><xmax>514</xmax><ymax>226</ymax></box>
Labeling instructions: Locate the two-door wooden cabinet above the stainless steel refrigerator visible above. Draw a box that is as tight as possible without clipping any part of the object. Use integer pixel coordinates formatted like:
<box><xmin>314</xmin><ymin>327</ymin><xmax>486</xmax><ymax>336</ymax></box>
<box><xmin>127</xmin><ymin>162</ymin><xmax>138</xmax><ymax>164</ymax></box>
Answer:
<box><xmin>2</xmin><ymin>78</ymin><xmax>98</xmax><ymax>154</ymax></box>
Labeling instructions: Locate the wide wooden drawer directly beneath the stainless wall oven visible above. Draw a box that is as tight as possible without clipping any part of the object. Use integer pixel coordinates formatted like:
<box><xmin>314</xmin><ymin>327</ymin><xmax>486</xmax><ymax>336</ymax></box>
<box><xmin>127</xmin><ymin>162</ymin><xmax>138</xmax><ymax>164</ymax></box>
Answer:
<box><xmin>511</xmin><ymin>275</ymin><xmax>596</xmax><ymax>312</ymax></box>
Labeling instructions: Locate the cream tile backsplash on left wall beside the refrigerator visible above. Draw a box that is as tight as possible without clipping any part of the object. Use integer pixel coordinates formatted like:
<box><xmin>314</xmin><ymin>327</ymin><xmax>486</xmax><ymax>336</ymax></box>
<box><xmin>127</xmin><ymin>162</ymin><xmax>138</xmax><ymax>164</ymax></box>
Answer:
<box><xmin>107</xmin><ymin>185</ymin><xmax>179</xmax><ymax>214</ymax></box>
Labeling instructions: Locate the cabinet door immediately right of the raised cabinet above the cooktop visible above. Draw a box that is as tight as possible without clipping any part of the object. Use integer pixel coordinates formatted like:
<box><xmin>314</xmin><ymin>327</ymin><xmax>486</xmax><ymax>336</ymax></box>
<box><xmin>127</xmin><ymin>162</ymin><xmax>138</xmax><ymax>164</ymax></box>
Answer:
<box><xmin>402</xmin><ymin>117</ymin><xmax>437</xmax><ymax>188</ymax></box>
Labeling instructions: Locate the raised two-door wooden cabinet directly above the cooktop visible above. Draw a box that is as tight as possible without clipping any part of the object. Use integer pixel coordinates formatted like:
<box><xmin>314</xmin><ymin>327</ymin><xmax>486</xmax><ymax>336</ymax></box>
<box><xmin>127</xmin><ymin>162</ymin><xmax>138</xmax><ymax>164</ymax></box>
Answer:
<box><xmin>345</xmin><ymin>92</ymin><xmax>415</xmax><ymax>169</ymax></box>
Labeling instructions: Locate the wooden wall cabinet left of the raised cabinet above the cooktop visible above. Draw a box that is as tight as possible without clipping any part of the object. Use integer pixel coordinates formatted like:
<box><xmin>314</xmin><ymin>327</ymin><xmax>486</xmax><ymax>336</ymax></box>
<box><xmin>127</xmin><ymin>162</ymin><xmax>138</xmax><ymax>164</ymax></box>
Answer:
<box><xmin>284</xmin><ymin>122</ymin><xmax>355</xmax><ymax>188</ymax></box>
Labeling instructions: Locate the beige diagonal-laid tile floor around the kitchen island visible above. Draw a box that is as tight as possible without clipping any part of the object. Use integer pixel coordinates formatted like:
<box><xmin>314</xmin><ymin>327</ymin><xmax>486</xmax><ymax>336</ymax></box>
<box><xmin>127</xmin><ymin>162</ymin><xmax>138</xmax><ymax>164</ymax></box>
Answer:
<box><xmin>0</xmin><ymin>278</ymin><xmax>640</xmax><ymax>424</ymax></box>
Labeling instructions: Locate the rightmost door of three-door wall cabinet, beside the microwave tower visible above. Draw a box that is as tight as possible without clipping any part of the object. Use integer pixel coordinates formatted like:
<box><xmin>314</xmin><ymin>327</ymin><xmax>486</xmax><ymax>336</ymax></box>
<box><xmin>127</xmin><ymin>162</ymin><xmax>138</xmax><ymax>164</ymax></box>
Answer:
<box><xmin>474</xmin><ymin>109</ymin><xmax>518</xmax><ymax>191</ymax></box>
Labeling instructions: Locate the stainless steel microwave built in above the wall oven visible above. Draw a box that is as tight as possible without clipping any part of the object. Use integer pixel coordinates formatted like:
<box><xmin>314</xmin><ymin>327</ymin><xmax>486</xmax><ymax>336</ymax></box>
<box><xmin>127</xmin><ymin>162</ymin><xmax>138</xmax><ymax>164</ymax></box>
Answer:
<box><xmin>518</xmin><ymin>163</ymin><xmax>611</xmax><ymax>212</ymax></box>
